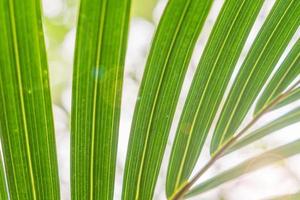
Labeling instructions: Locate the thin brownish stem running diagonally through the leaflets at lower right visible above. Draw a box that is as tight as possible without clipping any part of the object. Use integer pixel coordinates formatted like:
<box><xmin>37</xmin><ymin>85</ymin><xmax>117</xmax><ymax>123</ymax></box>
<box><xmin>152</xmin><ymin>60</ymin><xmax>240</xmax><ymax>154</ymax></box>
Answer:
<box><xmin>169</xmin><ymin>80</ymin><xmax>300</xmax><ymax>200</ymax></box>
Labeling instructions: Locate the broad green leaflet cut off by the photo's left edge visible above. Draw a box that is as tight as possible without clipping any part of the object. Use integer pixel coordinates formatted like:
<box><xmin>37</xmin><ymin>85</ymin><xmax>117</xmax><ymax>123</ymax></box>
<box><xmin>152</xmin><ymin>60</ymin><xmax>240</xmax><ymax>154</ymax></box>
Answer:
<box><xmin>0</xmin><ymin>0</ymin><xmax>60</xmax><ymax>200</ymax></box>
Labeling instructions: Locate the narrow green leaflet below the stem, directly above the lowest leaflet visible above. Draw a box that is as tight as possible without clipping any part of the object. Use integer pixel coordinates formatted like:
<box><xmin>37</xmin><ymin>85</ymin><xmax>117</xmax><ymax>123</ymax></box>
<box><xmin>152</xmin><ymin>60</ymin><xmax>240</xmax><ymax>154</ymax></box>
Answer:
<box><xmin>226</xmin><ymin>107</ymin><xmax>300</xmax><ymax>154</ymax></box>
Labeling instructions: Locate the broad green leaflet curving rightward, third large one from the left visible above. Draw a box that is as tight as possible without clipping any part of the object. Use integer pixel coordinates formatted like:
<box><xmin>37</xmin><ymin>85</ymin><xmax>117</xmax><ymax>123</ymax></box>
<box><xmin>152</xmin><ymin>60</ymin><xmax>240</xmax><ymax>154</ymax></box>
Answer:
<box><xmin>122</xmin><ymin>0</ymin><xmax>212</xmax><ymax>200</ymax></box>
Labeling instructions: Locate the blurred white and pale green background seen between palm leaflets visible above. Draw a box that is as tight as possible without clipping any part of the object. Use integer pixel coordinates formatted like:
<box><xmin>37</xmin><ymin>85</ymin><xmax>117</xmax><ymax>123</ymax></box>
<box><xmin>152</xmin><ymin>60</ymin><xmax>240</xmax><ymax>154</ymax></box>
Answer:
<box><xmin>43</xmin><ymin>0</ymin><xmax>300</xmax><ymax>200</ymax></box>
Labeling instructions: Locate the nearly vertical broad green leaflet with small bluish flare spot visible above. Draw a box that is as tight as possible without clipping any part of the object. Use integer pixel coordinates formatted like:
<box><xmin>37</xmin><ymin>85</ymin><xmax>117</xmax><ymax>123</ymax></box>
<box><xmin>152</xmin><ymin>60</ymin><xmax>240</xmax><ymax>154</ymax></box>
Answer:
<box><xmin>71</xmin><ymin>0</ymin><xmax>130</xmax><ymax>200</ymax></box>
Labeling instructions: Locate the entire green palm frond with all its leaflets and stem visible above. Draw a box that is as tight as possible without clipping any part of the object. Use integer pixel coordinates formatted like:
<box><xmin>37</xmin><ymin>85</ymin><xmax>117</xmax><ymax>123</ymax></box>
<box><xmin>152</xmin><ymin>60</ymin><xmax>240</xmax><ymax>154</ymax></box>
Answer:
<box><xmin>0</xmin><ymin>0</ymin><xmax>300</xmax><ymax>200</ymax></box>
